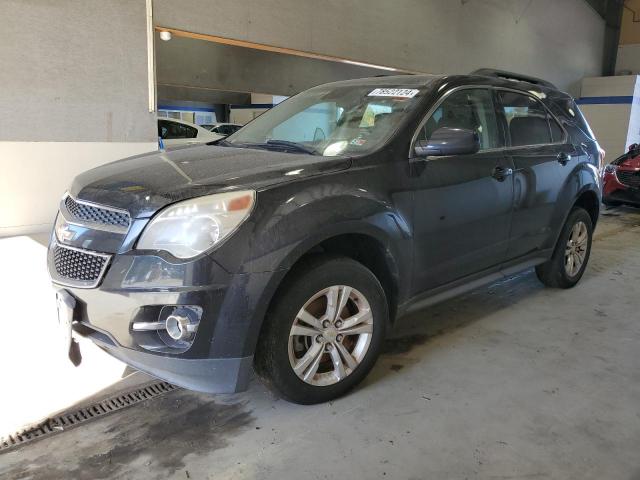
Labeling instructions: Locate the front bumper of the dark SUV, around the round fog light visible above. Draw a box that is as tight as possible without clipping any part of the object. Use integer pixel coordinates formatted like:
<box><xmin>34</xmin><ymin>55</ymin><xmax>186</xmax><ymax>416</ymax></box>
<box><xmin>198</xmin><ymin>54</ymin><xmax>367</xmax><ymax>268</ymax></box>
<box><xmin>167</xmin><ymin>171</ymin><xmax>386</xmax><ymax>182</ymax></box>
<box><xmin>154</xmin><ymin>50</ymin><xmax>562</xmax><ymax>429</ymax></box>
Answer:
<box><xmin>48</xmin><ymin>238</ymin><xmax>278</xmax><ymax>393</ymax></box>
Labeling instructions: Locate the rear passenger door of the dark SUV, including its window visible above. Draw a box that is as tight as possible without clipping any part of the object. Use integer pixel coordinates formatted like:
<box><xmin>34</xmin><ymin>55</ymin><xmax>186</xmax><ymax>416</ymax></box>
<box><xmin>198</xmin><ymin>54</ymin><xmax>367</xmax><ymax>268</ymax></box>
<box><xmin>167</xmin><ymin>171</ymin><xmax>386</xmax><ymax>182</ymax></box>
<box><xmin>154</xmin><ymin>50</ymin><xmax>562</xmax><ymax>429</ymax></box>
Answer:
<box><xmin>497</xmin><ymin>90</ymin><xmax>581</xmax><ymax>259</ymax></box>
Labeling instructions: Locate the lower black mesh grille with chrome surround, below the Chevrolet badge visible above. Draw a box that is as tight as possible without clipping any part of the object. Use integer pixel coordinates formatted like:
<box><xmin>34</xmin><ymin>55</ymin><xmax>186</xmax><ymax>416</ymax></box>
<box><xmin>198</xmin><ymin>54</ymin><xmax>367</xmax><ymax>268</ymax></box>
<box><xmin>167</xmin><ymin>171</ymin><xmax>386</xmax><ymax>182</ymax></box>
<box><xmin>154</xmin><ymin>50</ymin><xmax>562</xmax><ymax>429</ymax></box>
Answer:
<box><xmin>53</xmin><ymin>244</ymin><xmax>109</xmax><ymax>285</ymax></box>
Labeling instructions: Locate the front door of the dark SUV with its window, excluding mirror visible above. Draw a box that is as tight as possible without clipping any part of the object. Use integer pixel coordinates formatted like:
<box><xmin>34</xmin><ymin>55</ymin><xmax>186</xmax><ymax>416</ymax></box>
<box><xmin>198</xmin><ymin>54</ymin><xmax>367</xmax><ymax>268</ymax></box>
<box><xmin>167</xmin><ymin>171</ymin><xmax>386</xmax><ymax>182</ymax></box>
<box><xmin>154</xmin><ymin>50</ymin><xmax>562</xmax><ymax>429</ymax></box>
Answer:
<box><xmin>413</xmin><ymin>87</ymin><xmax>513</xmax><ymax>294</ymax></box>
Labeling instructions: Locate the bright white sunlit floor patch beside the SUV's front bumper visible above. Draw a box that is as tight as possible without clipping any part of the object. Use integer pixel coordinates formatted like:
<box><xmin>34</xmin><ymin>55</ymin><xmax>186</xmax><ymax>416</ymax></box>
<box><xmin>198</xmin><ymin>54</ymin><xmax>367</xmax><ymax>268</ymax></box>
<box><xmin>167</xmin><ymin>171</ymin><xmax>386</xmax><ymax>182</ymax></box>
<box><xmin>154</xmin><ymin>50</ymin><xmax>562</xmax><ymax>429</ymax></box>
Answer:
<box><xmin>0</xmin><ymin>234</ymin><xmax>125</xmax><ymax>436</ymax></box>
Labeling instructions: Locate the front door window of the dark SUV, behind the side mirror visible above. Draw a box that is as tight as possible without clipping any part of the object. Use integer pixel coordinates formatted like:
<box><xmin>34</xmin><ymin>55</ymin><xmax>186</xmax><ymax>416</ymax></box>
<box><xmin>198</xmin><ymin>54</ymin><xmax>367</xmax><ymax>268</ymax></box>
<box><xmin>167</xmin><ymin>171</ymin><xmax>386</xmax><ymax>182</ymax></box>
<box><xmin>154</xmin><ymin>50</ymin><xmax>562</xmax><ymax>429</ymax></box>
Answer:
<box><xmin>418</xmin><ymin>88</ymin><xmax>502</xmax><ymax>150</ymax></box>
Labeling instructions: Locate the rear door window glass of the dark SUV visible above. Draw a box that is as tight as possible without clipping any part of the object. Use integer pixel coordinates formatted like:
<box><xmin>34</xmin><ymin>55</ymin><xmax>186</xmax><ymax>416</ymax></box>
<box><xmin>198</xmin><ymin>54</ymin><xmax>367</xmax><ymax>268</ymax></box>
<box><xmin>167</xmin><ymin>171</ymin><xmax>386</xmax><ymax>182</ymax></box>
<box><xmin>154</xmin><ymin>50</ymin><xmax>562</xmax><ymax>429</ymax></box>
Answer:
<box><xmin>498</xmin><ymin>91</ymin><xmax>563</xmax><ymax>147</ymax></box>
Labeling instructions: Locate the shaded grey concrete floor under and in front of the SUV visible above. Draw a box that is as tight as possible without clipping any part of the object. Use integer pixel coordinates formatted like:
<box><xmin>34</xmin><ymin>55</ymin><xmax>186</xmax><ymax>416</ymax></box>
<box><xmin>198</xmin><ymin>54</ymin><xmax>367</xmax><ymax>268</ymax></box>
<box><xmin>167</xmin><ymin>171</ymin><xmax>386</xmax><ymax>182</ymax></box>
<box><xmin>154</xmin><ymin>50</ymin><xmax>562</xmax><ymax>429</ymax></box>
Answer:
<box><xmin>0</xmin><ymin>209</ymin><xmax>640</xmax><ymax>480</ymax></box>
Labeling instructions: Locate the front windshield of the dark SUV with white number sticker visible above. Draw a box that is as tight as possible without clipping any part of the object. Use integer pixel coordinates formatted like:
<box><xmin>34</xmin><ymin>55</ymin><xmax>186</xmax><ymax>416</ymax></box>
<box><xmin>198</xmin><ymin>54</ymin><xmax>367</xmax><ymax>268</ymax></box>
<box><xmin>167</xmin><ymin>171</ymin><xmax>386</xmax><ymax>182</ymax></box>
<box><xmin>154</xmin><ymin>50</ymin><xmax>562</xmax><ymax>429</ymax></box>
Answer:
<box><xmin>223</xmin><ymin>85</ymin><xmax>424</xmax><ymax>157</ymax></box>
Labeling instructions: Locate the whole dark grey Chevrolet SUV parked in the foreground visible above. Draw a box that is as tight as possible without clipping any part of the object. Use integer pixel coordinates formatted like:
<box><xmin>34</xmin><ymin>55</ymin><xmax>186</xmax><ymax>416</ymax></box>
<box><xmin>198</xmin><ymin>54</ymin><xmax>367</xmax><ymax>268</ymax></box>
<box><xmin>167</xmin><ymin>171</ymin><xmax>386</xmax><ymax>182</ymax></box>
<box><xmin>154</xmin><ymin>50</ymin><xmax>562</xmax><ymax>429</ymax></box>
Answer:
<box><xmin>48</xmin><ymin>71</ymin><xmax>602</xmax><ymax>403</ymax></box>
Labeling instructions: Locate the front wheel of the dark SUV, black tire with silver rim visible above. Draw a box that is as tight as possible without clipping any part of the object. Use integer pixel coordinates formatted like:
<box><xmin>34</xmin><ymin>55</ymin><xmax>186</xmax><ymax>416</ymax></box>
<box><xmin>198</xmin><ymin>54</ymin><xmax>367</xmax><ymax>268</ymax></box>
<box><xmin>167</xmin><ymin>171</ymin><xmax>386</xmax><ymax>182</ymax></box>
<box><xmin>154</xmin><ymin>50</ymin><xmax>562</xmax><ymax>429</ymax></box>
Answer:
<box><xmin>255</xmin><ymin>255</ymin><xmax>389</xmax><ymax>404</ymax></box>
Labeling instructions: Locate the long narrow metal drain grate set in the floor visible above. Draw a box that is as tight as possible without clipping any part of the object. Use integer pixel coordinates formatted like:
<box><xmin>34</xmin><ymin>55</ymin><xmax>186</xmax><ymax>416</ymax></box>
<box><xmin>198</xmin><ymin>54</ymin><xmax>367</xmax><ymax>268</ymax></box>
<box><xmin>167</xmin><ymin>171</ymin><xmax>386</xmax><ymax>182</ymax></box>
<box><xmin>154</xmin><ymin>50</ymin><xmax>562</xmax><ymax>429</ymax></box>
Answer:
<box><xmin>0</xmin><ymin>382</ymin><xmax>178</xmax><ymax>451</ymax></box>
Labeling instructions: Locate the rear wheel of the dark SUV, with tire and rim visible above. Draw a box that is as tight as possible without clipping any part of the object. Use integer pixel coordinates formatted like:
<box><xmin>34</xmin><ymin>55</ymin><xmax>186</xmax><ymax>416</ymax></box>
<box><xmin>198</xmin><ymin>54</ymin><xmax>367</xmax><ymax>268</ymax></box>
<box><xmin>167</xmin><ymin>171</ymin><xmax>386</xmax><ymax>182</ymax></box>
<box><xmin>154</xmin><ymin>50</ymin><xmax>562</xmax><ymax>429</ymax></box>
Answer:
<box><xmin>536</xmin><ymin>207</ymin><xmax>593</xmax><ymax>288</ymax></box>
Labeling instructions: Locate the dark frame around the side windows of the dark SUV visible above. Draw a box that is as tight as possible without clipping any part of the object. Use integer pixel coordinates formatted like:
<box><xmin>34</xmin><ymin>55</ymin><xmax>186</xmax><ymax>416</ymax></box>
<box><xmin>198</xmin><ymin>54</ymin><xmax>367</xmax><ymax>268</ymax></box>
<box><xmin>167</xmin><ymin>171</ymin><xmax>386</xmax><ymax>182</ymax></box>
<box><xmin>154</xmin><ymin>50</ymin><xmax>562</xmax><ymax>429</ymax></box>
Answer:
<box><xmin>408</xmin><ymin>84</ymin><xmax>569</xmax><ymax>159</ymax></box>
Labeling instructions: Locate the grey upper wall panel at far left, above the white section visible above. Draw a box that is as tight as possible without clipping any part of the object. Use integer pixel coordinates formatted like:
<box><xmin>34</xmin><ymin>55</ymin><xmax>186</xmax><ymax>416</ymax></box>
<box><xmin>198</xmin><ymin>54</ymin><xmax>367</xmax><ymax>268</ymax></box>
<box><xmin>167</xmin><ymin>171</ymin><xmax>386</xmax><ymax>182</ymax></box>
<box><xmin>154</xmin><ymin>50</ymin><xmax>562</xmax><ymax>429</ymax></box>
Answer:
<box><xmin>0</xmin><ymin>0</ymin><xmax>156</xmax><ymax>142</ymax></box>
